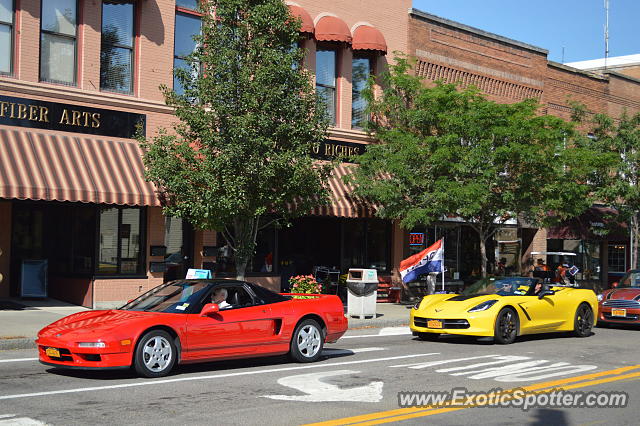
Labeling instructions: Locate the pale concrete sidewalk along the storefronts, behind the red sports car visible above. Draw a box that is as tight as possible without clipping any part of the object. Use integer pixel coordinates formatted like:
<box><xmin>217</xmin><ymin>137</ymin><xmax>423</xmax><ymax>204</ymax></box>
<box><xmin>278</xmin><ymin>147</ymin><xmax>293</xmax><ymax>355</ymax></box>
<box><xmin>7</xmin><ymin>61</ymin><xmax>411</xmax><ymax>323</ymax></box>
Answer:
<box><xmin>0</xmin><ymin>298</ymin><xmax>411</xmax><ymax>350</ymax></box>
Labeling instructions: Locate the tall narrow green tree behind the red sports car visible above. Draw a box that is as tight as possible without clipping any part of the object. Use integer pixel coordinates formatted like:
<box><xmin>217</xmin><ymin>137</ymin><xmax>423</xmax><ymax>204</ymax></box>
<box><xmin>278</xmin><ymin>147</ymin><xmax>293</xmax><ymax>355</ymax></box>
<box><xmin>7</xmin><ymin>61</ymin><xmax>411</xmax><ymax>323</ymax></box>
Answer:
<box><xmin>140</xmin><ymin>0</ymin><xmax>331</xmax><ymax>279</ymax></box>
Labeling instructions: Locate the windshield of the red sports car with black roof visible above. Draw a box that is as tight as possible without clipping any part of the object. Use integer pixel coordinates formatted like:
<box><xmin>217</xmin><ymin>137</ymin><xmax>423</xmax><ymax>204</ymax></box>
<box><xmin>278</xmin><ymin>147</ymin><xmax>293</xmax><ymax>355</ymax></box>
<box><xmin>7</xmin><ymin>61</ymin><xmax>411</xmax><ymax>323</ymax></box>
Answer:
<box><xmin>120</xmin><ymin>281</ymin><xmax>209</xmax><ymax>313</ymax></box>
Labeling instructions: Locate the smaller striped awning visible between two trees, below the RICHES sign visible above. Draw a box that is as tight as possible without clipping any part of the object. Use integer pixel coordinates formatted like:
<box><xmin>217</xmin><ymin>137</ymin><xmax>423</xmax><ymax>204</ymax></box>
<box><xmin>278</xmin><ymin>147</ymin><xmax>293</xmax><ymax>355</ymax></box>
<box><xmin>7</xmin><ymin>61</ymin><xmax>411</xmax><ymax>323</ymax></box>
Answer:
<box><xmin>308</xmin><ymin>163</ymin><xmax>376</xmax><ymax>218</ymax></box>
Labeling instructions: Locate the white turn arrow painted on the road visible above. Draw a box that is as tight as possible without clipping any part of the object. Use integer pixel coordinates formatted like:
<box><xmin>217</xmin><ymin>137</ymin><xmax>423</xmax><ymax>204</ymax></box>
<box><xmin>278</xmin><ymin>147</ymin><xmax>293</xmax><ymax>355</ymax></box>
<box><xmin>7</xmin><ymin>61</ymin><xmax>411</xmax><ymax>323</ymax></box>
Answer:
<box><xmin>263</xmin><ymin>370</ymin><xmax>383</xmax><ymax>402</ymax></box>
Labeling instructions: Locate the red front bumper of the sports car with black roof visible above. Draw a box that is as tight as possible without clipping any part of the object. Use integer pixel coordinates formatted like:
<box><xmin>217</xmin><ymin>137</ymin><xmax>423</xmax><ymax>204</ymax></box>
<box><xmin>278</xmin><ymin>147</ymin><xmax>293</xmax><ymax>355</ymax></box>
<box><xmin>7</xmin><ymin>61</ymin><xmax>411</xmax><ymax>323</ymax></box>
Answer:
<box><xmin>36</xmin><ymin>338</ymin><xmax>132</xmax><ymax>370</ymax></box>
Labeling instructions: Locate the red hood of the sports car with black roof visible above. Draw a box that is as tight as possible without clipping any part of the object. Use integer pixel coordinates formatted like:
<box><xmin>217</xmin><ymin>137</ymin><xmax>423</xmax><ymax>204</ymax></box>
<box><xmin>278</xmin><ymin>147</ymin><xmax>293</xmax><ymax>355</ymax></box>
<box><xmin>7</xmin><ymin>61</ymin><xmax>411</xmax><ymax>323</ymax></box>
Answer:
<box><xmin>38</xmin><ymin>310</ymin><xmax>154</xmax><ymax>338</ymax></box>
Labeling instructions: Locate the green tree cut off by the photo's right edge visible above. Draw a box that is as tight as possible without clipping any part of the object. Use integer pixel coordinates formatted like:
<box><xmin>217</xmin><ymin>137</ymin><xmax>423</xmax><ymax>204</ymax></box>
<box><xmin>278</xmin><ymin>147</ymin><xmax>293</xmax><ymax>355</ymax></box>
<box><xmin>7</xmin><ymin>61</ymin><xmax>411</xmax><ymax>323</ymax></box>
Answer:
<box><xmin>573</xmin><ymin>109</ymin><xmax>640</xmax><ymax>269</ymax></box>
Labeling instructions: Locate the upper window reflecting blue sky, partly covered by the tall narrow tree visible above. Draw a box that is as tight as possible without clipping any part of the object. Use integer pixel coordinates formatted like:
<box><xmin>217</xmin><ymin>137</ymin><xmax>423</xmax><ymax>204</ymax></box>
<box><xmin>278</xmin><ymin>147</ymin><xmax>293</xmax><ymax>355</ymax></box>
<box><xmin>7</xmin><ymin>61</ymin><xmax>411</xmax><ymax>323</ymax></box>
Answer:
<box><xmin>173</xmin><ymin>0</ymin><xmax>202</xmax><ymax>94</ymax></box>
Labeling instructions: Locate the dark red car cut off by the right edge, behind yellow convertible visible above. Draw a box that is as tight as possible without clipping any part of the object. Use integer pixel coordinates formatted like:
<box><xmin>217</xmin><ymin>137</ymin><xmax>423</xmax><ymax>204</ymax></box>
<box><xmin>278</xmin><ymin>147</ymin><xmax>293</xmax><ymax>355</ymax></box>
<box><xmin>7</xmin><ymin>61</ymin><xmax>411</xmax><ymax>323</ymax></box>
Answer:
<box><xmin>598</xmin><ymin>269</ymin><xmax>640</xmax><ymax>324</ymax></box>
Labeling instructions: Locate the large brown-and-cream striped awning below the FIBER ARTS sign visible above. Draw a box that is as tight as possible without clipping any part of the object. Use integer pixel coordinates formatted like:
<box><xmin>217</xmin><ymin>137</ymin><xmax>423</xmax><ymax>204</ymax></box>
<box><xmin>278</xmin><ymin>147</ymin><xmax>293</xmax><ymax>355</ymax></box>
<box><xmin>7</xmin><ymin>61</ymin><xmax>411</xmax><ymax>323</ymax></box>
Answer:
<box><xmin>0</xmin><ymin>128</ymin><xmax>160</xmax><ymax>206</ymax></box>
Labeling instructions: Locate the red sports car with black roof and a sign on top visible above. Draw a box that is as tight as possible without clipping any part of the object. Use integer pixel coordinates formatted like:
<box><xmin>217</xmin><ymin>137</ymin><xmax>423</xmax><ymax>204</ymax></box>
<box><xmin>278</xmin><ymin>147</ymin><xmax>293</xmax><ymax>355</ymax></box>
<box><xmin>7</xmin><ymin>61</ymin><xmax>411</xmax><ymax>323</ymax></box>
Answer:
<box><xmin>36</xmin><ymin>280</ymin><xmax>347</xmax><ymax>377</ymax></box>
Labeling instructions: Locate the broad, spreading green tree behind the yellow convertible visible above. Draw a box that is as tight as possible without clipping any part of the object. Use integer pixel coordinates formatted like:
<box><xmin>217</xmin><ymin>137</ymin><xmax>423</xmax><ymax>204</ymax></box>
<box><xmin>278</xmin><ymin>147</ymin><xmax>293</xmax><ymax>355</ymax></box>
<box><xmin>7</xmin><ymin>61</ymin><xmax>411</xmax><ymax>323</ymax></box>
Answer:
<box><xmin>354</xmin><ymin>58</ymin><xmax>597</xmax><ymax>276</ymax></box>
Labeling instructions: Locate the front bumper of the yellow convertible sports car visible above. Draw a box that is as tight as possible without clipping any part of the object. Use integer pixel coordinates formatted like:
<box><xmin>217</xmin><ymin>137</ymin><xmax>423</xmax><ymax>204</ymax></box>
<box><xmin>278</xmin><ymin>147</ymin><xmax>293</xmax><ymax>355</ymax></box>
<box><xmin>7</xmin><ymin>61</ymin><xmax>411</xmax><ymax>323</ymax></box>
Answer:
<box><xmin>409</xmin><ymin>309</ymin><xmax>495</xmax><ymax>337</ymax></box>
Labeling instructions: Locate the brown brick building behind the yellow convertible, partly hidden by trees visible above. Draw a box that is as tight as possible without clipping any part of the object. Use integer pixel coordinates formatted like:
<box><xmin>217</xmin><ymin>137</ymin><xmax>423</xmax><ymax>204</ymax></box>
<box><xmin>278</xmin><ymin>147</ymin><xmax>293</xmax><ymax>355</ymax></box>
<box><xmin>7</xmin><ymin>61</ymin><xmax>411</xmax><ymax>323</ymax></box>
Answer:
<box><xmin>408</xmin><ymin>9</ymin><xmax>640</xmax><ymax>290</ymax></box>
